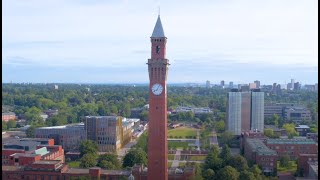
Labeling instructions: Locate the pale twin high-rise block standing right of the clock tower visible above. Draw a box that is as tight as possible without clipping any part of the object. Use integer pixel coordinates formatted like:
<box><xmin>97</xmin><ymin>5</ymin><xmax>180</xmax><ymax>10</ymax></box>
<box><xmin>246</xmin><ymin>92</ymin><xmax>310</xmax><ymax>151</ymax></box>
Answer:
<box><xmin>226</xmin><ymin>89</ymin><xmax>264</xmax><ymax>135</ymax></box>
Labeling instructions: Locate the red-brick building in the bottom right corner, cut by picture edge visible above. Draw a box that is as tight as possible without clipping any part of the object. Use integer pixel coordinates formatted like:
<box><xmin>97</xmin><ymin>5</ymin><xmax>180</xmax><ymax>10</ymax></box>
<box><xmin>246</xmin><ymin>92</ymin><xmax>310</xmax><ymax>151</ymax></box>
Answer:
<box><xmin>297</xmin><ymin>154</ymin><xmax>318</xmax><ymax>177</ymax></box>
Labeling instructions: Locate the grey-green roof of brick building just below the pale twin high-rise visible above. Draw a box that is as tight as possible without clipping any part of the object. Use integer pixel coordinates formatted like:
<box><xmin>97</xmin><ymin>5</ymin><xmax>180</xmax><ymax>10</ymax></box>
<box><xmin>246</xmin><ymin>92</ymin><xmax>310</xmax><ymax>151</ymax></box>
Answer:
<box><xmin>246</xmin><ymin>138</ymin><xmax>277</xmax><ymax>155</ymax></box>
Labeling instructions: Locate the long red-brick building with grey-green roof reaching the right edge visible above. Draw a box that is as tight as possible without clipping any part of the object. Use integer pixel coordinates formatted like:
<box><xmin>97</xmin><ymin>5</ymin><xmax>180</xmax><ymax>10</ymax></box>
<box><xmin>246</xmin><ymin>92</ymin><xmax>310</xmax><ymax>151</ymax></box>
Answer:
<box><xmin>266</xmin><ymin>138</ymin><xmax>318</xmax><ymax>159</ymax></box>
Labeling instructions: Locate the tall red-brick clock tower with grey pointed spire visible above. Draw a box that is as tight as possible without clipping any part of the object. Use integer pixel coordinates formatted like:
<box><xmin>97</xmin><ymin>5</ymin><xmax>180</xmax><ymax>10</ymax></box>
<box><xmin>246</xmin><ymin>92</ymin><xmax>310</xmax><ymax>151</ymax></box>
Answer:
<box><xmin>147</xmin><ymin>15</ymin><xmax>170</xmax><ymax>180</ymax></box>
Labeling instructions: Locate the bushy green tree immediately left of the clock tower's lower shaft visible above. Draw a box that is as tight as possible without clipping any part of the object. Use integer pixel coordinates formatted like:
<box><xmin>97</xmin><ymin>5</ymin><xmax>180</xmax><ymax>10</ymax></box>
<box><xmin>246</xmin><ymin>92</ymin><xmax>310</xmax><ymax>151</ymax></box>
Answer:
<box><xmin>122</xmin><ymin>148</ymin><xmax>147</xmax><ymax>168</ymax></box>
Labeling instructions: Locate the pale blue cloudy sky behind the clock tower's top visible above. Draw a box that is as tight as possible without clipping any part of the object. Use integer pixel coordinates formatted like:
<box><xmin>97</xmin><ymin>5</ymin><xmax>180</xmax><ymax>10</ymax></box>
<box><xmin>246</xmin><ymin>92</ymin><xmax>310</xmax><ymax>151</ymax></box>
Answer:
<box><xmin>2</xmin><ymin>0</ymin><xmax>318</xmax><ymax>84</ymax></box>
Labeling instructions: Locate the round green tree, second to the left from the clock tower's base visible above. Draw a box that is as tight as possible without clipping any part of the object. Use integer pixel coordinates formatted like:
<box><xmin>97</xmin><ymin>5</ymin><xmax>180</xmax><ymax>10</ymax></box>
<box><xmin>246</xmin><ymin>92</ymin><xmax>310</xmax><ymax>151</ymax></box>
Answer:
<box><xmin>97</xmin><ymin>154</ymin><xmax>121</xmax><ymax>170</ymax></box>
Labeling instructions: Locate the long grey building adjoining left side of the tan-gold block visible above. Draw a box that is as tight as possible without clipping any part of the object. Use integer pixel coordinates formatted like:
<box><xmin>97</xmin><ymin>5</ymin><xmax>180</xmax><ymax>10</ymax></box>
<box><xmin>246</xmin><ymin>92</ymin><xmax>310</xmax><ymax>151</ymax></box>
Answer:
<box><xmin>35</xmin><ymin>123</ymin><xmax>87</xmax><ymax>152</ymax></box>
